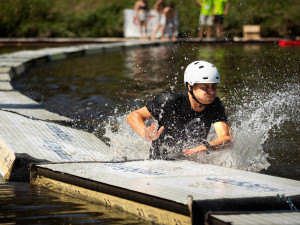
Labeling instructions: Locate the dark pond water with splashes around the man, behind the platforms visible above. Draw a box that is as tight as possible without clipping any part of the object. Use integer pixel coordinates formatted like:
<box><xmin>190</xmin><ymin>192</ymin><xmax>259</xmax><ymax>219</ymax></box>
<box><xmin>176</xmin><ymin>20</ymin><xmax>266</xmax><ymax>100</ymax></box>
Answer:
<box><xmin>0</xmin><ymin>44</ymin><xmax>300</xmax><ymax>223</ymax></box>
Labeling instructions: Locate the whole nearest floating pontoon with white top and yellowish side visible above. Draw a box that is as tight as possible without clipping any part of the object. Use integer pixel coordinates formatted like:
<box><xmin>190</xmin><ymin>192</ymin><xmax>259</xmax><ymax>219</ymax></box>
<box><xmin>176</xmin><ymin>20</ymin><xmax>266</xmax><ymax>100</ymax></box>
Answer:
<box><xmin>31</xmin><ymin>160</ymin><xmax>300</xmax><ymax>224</ymax></box>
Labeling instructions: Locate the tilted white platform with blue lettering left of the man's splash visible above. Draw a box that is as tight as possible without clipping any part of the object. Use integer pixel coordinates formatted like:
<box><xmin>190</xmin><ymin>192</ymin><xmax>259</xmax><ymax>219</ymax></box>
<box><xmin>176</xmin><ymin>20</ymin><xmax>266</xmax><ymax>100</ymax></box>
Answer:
<box><xmin>0</xmin><ymin>110</ymin><xmax>109</xmax><ymax>179</ymax></box>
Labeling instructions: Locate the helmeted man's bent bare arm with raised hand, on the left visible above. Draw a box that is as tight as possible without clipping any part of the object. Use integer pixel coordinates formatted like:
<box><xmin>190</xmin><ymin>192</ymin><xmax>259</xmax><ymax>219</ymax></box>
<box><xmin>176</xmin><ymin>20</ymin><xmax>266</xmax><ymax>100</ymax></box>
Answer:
<box><xmin>126</xmin><ymin>106</ymin><xmax>164</xmax><ymax>141</ymax></box>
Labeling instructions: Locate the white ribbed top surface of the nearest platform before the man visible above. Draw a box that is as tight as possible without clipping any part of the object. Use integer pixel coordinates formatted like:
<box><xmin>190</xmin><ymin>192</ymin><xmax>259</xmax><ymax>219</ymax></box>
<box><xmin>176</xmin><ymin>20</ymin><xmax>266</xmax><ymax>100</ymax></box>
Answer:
<box><xmin>35</xmin><ymin>160</ymin><xmax>300</xmax><ymax>204</ymax></box>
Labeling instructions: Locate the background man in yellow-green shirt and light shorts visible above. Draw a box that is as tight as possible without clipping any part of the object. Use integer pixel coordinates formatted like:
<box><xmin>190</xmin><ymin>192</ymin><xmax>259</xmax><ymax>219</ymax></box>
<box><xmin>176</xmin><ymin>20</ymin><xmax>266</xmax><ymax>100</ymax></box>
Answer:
<box><xmin>196</xmin><ymin>0</ymin><xmax>213</xmax><ymax>39</ymax></box>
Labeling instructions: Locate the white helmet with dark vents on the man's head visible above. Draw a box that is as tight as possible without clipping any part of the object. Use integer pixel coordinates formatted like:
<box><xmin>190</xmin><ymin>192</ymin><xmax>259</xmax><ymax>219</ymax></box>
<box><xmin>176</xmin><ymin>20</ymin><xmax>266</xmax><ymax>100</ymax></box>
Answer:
<box><xmin>184</xmin><ymin>61</ymin><xmax>220</xmax><ymax>86</ymax></box>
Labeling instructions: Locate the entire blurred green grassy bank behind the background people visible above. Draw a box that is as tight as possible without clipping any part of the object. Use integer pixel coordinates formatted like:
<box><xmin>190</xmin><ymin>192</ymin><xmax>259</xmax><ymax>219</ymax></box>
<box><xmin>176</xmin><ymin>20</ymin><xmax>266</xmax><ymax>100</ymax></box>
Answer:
<box><xmin>0</xmin><ymin>0</ymin><xmax>300</xmax><ymax>37</ymax></box>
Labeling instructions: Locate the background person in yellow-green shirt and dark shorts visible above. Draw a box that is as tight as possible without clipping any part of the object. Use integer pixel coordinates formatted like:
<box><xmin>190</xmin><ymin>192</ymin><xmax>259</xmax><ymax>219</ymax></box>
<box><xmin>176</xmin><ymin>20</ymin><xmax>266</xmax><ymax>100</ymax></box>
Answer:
<box><xmin>213</xmin><ymin>0</ymin><xmax>230</xmax><ymax>38</ymax></box>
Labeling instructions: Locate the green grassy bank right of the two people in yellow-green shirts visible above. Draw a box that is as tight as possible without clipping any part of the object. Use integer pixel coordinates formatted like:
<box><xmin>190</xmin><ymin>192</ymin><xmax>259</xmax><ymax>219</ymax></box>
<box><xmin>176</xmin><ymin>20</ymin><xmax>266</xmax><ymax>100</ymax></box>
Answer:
<box><xmin>225</xmin><ymin>0</ymin><xmax>300</xmax><ymax>36</ymax></box>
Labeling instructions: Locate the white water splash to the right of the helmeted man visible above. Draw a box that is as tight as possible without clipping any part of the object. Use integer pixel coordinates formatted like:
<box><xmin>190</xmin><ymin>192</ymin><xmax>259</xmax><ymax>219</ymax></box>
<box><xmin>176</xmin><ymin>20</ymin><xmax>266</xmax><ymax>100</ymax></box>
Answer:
<box><xmin>195</xmin><ymin>83</ymin><xmax>300</xmax><ymax>172</ymax></box>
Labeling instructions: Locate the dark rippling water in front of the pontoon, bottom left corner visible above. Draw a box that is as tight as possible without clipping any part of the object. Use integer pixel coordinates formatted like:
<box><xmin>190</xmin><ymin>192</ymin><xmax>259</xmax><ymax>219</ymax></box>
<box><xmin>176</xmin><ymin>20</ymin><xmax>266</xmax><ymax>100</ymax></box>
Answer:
<box><xmin>0</xmin><ymin>178</ymin><xmax>151</xmax><ymax>225</ymax></box>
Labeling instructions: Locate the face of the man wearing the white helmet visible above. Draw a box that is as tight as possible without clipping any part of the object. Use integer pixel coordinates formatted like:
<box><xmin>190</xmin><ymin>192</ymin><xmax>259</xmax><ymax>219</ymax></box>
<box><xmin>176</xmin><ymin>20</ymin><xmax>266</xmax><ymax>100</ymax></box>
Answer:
<box><xmin>193</xmin><ymin>83</ymin><xmax>217</xmax><ymax>104</ymax></box>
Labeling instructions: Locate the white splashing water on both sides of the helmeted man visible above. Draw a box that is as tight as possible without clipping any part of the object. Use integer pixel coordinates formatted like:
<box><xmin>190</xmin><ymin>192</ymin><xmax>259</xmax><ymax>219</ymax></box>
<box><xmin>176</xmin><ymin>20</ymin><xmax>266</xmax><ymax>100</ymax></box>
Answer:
<box><xmin>105</xmin><ymin>81</ymin><xmax>300</xmax><ymax>172</ymax></box>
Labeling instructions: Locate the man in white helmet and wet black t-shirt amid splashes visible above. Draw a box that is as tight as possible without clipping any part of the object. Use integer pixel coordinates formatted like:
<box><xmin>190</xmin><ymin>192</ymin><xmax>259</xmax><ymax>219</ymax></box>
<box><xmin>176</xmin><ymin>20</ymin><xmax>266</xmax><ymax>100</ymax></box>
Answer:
<box><xmin>126</xmin><ymin>61</ymin><xmax>232</xmax><ymax>159</ymax></box>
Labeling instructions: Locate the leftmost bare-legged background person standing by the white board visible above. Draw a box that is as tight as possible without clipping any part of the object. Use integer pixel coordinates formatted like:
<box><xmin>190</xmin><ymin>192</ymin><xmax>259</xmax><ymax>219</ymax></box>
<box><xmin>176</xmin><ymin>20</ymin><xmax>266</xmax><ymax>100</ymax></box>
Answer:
<box><xmin>134</xmin><ymin>0</ymin><xmax>149</xmax><ymax>40</ymax></box>
